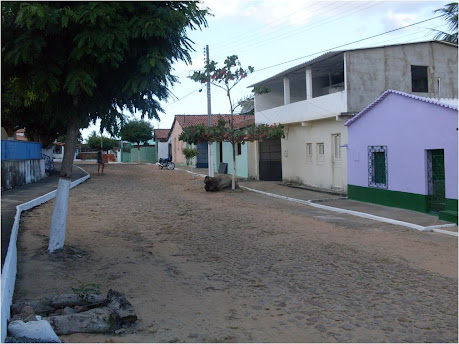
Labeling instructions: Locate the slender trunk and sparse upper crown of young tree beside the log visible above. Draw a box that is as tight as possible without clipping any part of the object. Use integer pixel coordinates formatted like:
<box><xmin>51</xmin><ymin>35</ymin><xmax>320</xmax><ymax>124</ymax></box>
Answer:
<box><xmin>190</xmin><ymin>55</ymin><xmax>254</xmax><ymax>190</ymax></box>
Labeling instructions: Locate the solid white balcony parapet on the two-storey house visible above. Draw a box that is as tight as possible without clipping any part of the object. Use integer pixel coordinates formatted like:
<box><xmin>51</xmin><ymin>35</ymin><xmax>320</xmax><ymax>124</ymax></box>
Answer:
<box><xmin>255</xmin><ymin>90</ymin><xmax>347</xmax><ymax>124</ymax></box>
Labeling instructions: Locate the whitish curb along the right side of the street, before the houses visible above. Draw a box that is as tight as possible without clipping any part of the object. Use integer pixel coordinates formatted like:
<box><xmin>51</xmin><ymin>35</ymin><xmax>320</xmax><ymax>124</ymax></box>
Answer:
<box><xmin>176</xmin><ymin>168</ymin><xmax>458</xmax><ymax>237</ymax></box>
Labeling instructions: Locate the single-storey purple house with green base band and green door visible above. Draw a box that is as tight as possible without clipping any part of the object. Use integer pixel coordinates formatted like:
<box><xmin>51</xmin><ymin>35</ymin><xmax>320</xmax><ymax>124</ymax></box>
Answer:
<box><xmin>345</xmin><ymin>90</ymin><xmax>458</xmax><ymax>223</ymax></box>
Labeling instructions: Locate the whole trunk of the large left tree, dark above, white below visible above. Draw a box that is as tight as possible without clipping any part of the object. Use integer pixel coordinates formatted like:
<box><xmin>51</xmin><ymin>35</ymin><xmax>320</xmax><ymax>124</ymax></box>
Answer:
<box><xmin>48</xmin><ymin>118</ymin><xmax>80</xmax><ymax>253</ymax></box>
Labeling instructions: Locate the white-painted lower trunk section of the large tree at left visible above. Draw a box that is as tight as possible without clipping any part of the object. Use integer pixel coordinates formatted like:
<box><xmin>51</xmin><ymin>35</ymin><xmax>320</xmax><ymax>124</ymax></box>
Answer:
<box><xmin>48</xmin><ymin>178</ymin><xmax>71</xmax><ymax>253</ymax></box>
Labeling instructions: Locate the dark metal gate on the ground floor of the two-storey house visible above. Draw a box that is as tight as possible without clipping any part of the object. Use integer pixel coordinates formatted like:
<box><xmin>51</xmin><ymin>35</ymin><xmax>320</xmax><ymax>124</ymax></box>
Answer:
<box><xmin>259</xmin><ymin>139</ymin><xmax>282</xmax><ymax>180</ymax></box>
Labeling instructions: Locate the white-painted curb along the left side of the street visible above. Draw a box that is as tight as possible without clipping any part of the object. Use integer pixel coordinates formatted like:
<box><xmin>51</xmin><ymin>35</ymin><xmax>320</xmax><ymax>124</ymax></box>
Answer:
<box><xmin>1</xmin><ymin>165</ymin><xmax>91</xmax><ymax>343</ymax></box>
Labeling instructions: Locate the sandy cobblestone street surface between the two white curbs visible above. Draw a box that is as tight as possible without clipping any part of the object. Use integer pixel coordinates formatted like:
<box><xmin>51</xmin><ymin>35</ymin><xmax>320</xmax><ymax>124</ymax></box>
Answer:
<box><xmin>15</xmin><ymin>164</ymin><xmax>458</xmax><ymax>342</ymax></box>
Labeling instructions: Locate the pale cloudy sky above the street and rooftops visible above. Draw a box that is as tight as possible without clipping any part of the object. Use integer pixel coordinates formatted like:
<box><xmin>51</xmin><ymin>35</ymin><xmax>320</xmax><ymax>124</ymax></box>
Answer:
<box><xmin>82</xmin><ymin>0</ymin><xmax>449</xmax><ymax>139</ymax></box>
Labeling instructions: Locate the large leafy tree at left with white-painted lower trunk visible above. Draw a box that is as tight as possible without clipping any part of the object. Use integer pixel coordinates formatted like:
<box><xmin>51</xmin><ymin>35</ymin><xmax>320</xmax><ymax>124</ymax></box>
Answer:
<box><xmin>1</xmin><ymin>1</ymin><xmax>208</xmax><ymax>252</ymax></box>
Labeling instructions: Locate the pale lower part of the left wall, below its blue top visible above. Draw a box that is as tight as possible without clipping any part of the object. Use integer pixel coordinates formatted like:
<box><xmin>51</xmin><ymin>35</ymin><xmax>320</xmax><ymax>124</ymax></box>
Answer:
<box><xmin>2</xmin><ymin>159</ymin><xmax>46</xmax><ymax>190</ymax></box>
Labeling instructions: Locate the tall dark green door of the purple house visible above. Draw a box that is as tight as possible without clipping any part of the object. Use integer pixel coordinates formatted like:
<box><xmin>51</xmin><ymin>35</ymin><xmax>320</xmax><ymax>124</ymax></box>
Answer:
<box><xmin>427</xmin><ymin>149</ymin><xmax>446</xmax><ymax>212</ymax></box>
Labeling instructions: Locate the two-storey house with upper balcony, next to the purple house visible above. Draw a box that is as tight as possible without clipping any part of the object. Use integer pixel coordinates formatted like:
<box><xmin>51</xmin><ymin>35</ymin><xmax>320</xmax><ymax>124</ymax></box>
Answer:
<box><xmin>249</xmin><ymin>41</ymin><xmax>458</xmax><ymax>192</ymax></box>
